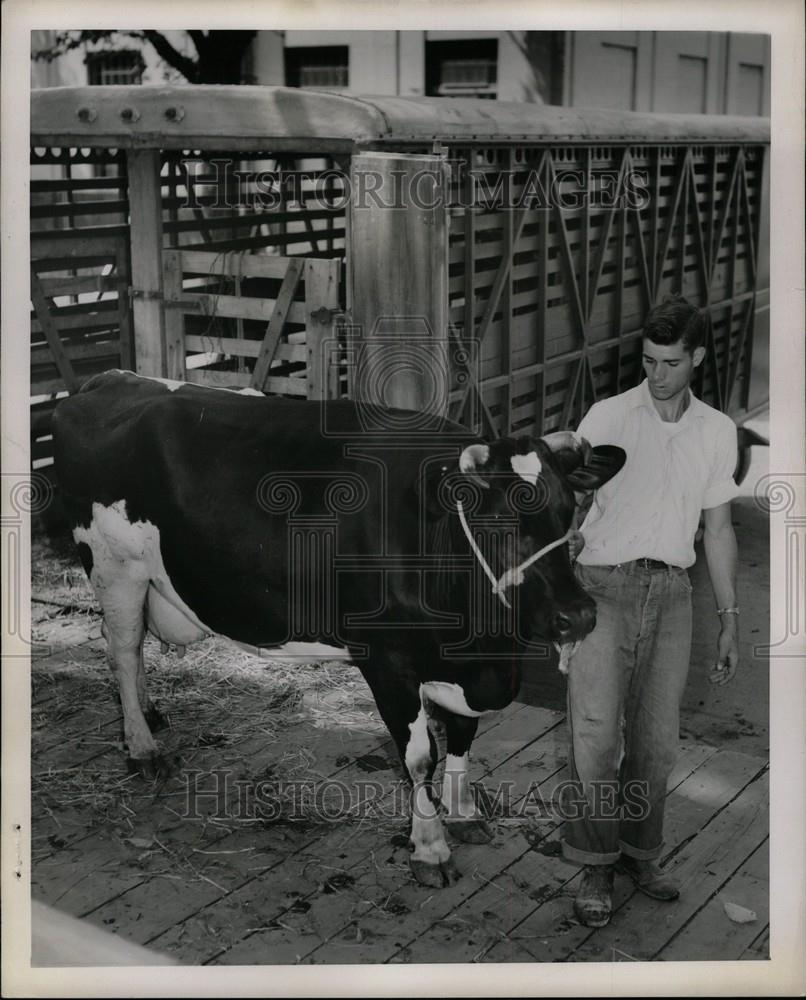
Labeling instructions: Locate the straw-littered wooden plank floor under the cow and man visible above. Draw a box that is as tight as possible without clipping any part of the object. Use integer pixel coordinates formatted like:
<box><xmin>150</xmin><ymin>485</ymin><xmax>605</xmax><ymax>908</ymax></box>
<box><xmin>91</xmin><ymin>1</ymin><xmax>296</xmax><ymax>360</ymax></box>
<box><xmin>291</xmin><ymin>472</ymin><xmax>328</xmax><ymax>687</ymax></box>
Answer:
<box><xmin>32</xmin><ymin>623</ymin><xmax>769</xmax><ymax>965</ymax></box>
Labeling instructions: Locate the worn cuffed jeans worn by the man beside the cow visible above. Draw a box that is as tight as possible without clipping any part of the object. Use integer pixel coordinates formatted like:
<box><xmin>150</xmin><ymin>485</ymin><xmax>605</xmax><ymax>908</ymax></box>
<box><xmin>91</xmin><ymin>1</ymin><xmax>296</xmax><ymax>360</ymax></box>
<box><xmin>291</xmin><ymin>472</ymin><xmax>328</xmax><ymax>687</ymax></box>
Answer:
<box><xmin>563</xmin><ymin>563</ymin><xmax>691</xmax><ymax>865</ymax></box>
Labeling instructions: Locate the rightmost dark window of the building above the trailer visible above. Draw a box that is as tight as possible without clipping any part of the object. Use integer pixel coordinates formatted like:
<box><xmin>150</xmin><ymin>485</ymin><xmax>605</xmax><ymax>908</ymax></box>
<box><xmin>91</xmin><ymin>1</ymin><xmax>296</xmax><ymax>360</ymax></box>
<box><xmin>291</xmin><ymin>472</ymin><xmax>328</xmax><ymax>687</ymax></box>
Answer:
<box><xmin>425</xmin><ymin>38</ymin><xmax>498</xmax><ymax>98</ymax></box>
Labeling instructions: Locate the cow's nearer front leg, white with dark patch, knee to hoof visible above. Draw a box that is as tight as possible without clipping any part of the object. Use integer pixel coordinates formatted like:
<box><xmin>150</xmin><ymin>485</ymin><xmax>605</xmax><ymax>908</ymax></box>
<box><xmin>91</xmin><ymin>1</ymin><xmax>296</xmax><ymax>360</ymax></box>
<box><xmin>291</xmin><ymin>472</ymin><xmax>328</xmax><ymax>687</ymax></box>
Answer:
<box><xmin>404</xmin><ymin>703</ymin><xmax>459</xmax><ymax>889</ymax></box>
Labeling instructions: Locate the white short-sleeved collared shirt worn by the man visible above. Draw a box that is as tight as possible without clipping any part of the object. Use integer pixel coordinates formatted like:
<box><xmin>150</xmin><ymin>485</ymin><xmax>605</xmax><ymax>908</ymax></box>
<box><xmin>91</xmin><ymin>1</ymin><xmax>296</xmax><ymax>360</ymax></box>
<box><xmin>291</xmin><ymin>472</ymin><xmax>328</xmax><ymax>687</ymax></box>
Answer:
<box><xmin>578</xmin><ymin>380</ymin><xmax>738</xmax><ymax>567</ymax></box>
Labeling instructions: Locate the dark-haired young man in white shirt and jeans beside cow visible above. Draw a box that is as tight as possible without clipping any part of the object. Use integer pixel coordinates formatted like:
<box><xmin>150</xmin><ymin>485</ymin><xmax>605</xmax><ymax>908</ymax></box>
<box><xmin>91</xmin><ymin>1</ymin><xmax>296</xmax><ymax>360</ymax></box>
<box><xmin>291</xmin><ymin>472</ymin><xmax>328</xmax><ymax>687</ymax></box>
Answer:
<box><xmin>563</xmin><ymin>297</ymin><xmax>739</xmax><ymax>927</ymax></box>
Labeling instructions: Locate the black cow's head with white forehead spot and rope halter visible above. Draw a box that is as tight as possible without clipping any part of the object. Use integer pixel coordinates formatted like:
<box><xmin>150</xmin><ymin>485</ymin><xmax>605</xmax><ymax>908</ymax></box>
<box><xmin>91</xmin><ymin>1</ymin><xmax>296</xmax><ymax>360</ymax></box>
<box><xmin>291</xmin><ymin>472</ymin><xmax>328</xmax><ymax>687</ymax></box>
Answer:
<box><xmin>459</xmin><ymin>432</ymin><xmax>625</xmax><ymax>645</ymax></box>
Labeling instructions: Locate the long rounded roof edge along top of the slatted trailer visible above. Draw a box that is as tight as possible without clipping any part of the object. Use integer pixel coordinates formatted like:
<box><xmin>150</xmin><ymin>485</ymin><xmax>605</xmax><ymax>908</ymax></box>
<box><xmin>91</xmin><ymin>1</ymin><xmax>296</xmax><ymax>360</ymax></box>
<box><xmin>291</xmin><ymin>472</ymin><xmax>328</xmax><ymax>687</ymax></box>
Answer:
<box><xmin>31</xmin><ymin>85</ymin><xmax>770</xmax><ymax>153</ymax></box>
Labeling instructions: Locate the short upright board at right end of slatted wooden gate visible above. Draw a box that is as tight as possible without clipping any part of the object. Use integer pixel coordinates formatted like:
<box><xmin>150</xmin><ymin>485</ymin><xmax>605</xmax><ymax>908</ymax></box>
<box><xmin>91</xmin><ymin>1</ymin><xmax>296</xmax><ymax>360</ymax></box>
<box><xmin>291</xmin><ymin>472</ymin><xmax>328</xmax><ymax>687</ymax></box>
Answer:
<box><xmin>305</xmin><ymin>257</ymin><xmax>341</xmax><ymax>399</ymax></box>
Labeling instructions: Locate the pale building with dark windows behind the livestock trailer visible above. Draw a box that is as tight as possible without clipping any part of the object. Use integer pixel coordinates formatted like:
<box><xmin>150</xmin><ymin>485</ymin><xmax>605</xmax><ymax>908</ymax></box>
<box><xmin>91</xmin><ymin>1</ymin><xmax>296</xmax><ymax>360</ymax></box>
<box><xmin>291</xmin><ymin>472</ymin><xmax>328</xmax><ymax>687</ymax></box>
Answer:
<box><xmin>32</xmin><ymin>31</ymin><xmax>770</xmax><ymax>115</ymax></box>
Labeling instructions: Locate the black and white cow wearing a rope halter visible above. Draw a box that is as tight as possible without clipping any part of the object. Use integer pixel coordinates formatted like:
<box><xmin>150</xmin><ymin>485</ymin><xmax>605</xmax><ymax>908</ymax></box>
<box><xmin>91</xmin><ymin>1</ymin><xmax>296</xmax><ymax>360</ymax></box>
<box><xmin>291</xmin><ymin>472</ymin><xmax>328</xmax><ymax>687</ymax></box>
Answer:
<box><xmin>53</xmin><ymin>371</ymin><xmax>624</xmax><ymax>887</ymax></box>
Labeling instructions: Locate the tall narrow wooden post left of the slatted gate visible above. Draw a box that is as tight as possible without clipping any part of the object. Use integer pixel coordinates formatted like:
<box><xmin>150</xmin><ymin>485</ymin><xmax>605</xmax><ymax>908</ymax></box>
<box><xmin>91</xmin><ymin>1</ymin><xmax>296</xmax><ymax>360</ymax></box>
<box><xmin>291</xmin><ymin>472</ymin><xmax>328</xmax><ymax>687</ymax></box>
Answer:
<box><xmin>126</xmin><ymin>149</ymin><xmax>168</xmax><ymax>377</ymax></box>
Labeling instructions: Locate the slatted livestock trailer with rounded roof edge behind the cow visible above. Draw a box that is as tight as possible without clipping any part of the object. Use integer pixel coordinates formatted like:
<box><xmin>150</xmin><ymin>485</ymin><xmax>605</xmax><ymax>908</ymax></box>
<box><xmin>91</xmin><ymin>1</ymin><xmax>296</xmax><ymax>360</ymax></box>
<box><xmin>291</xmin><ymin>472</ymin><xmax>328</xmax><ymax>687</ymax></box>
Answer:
<box><xmin>31</xmin><ymin>86</ymin><xmax>769</xmax><ymax>471</ymax></box>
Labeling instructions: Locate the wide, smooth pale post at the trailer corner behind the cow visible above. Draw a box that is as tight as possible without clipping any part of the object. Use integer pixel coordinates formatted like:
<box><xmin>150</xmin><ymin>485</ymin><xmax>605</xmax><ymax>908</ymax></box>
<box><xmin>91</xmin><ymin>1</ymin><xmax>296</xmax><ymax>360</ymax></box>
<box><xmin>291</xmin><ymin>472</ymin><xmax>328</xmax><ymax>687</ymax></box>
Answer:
<box><xmin>350</xmin><ymin>153</ymin><xmax>451</xmax><ymax>416</ymax></box>
